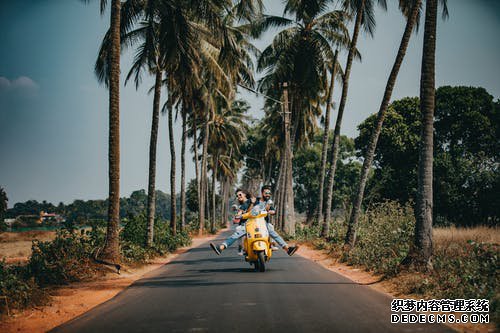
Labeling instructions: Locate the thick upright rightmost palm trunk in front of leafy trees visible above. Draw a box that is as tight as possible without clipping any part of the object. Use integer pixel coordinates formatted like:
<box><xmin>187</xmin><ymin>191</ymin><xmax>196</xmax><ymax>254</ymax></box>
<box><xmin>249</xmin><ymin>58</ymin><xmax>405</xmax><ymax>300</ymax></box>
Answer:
<box><xmin>405</xmin><ymin>0</ymin><xmax>437</xmax><ymax>269</ymax></box>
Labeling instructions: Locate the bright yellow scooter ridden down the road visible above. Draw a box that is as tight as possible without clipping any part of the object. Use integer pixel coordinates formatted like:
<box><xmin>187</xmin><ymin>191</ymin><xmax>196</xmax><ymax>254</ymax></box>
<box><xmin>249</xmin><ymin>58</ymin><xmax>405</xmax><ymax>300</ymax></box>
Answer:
<box><xmin>241</xmin><ymin>206</ymin><xmax>273</xmax><ymax>272</ymax></box>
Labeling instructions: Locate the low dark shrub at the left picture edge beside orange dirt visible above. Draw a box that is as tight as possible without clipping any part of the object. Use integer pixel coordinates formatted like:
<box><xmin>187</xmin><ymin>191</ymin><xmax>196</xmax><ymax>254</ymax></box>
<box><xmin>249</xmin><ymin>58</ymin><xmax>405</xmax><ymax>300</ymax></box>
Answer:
<box><xmin>0</xmin><ymin>261</ymin><xmax>48</xmax><ymax>313</ymax></box>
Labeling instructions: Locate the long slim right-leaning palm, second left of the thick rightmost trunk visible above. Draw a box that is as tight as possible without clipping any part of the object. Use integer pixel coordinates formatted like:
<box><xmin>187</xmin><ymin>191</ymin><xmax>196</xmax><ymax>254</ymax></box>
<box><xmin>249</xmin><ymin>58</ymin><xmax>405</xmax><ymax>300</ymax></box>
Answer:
<box><xmin>321</xmin><ymin>0</ymin><xmax>387</xmax><ymax>237</ymax></box>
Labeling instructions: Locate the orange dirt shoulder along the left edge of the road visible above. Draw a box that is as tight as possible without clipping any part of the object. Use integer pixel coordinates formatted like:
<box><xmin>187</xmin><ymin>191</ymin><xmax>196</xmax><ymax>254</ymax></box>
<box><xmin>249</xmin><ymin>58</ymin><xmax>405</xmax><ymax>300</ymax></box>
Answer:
<box><xmin>0</xmin><ymin>229</ymin><xmax>225</xmax><ymax>333</ymax></box>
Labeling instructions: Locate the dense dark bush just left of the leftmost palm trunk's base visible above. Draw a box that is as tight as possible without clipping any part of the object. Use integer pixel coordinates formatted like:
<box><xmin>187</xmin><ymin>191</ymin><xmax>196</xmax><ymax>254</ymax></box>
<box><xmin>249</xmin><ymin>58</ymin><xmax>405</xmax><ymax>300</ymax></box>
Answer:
<box><xmin>27</xmin><ymin>229</ymin><xmax>96</xmax><ymax>286</ymax></box>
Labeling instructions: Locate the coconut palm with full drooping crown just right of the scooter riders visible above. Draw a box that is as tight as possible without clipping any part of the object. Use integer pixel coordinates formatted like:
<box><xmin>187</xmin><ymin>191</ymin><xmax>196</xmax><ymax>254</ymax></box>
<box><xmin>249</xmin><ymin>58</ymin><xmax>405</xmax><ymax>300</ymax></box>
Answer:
<box><xmin>253</xmin><ymin>0</ymin><xmax>348</xmax><ymax>234</ymax></box>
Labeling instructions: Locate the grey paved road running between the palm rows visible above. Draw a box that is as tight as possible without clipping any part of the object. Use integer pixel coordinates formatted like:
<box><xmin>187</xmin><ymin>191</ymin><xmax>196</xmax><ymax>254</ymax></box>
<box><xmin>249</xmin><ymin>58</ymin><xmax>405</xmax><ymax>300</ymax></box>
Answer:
<box><xmin>53</xmin><ymin>232</ymin><xmax>452</xmax><ymax>333</ymax></box>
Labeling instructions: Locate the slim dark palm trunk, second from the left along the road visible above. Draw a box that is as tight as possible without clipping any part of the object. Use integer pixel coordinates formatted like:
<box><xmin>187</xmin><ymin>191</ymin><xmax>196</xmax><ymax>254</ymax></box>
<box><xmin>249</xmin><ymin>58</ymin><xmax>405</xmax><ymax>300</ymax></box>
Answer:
<box><xmin>146</xmin><ymin>70</ymin><xmax>163</xmax><ymax>247</ymax></box>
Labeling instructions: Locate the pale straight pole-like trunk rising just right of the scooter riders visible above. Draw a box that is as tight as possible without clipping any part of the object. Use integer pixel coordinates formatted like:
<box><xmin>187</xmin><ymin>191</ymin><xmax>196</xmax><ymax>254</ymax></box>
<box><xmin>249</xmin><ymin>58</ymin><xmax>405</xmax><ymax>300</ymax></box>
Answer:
<box><xmin>283</xmin><ymin>82</ymin><xmax>295</xmax><ymax>235</ymax></box>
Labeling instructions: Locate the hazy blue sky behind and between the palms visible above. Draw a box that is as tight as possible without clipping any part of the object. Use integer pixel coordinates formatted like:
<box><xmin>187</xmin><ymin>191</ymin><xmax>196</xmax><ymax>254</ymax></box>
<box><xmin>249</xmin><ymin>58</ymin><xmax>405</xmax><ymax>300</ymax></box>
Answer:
<box><xmin>0</xmin><ymin>0</ymin><xmax>500</xmax><ymax>206</ymax></box>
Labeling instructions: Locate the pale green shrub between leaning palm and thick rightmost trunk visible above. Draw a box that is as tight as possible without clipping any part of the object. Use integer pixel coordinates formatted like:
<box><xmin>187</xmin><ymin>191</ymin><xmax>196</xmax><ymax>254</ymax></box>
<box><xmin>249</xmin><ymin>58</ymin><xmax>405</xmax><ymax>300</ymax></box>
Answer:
<box><xmin>347</xmin><ymin>201</ymin><xmax>415</xmax><ymax>276</ymax></box>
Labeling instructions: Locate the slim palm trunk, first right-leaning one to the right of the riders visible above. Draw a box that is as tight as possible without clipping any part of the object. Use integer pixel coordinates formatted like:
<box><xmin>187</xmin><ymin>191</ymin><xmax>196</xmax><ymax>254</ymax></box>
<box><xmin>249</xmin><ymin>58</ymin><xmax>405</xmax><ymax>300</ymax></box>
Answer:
<box><xmin>316</xmin><ymin>50</ymin><xmax>339</xmax><ymax>223</ymax></box>
